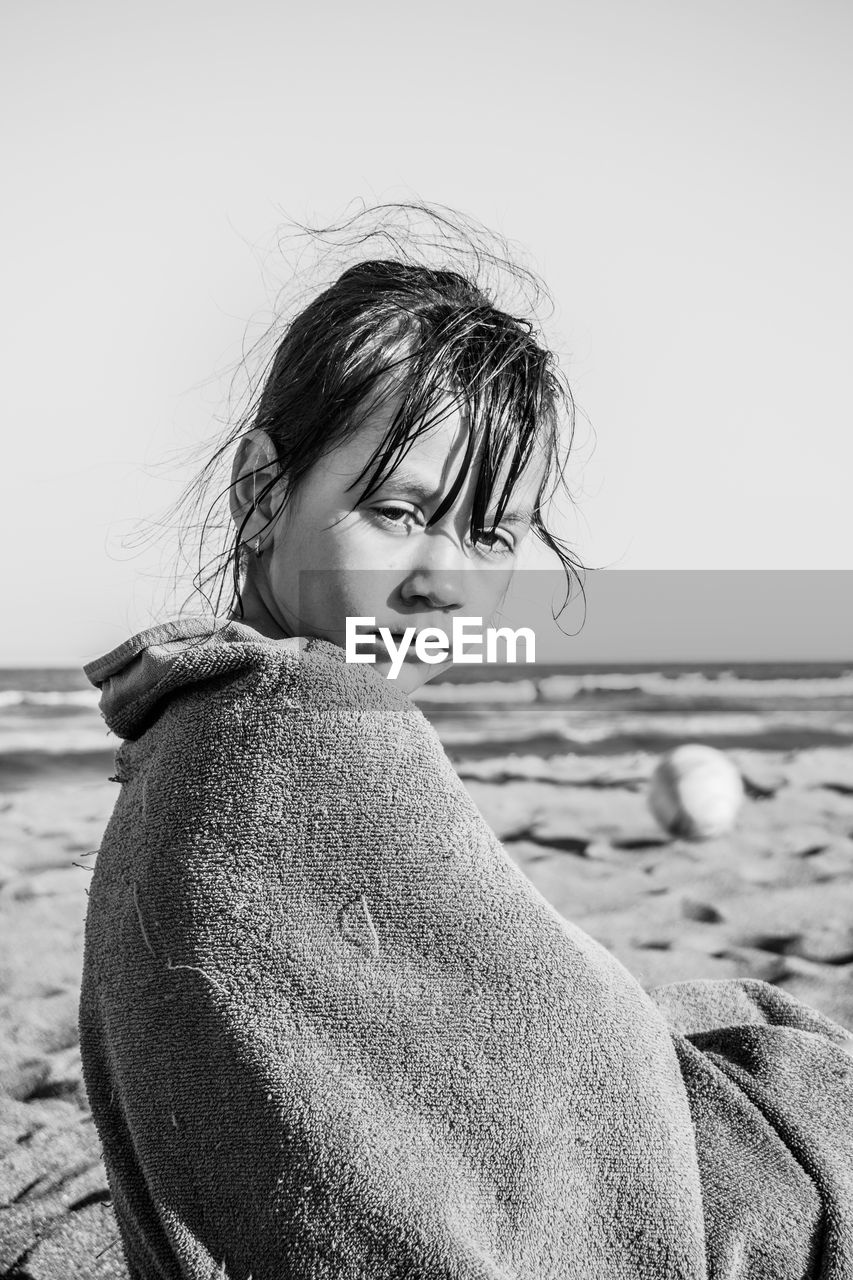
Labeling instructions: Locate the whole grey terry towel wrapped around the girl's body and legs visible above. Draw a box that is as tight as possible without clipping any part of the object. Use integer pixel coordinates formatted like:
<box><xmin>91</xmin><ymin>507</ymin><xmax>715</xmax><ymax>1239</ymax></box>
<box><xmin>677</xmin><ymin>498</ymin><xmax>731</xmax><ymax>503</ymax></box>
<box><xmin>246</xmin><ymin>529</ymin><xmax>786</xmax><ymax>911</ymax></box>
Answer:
<box><xmin>81</xmin><ymin>621</ymin><xmax>853</xmax><ymax>1280</ymax></box>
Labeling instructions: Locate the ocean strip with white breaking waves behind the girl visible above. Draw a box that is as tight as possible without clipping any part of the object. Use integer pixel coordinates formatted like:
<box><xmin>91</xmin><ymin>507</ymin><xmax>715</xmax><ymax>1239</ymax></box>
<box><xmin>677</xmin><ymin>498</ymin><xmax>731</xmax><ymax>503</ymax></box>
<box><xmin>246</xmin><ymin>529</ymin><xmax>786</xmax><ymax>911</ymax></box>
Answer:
<box><xmin>0</xmin><ymin>663</ymin><xmax>853</xmax><ymax>791</ymax></box>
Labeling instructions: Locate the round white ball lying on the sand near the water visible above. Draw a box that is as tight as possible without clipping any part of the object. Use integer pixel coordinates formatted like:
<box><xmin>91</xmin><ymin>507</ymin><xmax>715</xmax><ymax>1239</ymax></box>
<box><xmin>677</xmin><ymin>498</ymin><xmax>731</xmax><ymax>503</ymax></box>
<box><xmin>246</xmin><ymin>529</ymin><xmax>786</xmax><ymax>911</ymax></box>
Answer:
<box><xmin>648</xmin><ymin>742</ymin><xmax>743</xmax><ymax>840</ymax></box>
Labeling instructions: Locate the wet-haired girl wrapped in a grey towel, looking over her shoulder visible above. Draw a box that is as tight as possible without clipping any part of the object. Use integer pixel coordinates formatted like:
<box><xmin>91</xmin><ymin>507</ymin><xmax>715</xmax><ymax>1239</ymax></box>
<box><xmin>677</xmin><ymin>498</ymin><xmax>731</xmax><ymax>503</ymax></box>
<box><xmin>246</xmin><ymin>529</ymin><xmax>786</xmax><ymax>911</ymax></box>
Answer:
<box><xmin>81</xmin><ymin>204</ymin><xmax>853</xmax><ymax>1280</ymax></box>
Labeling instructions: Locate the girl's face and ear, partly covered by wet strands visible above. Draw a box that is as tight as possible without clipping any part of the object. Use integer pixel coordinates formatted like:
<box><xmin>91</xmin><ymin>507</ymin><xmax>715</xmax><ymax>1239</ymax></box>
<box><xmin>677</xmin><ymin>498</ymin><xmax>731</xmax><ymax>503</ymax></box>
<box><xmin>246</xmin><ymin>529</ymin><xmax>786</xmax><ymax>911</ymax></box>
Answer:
<box><xmin>232</xmin><ymin>404</ymin><xmax>546</xmax><ymax>692</ymax></box>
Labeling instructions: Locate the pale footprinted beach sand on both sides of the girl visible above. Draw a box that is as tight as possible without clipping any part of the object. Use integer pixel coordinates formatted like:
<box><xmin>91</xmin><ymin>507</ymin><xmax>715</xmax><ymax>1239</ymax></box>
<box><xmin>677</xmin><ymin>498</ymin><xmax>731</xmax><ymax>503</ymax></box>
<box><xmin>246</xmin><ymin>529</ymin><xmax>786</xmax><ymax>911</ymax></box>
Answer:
<box><xmin>0</xmin><ymin>749</ymin><xmax>853</xmax><ymax>1280</ymax></box>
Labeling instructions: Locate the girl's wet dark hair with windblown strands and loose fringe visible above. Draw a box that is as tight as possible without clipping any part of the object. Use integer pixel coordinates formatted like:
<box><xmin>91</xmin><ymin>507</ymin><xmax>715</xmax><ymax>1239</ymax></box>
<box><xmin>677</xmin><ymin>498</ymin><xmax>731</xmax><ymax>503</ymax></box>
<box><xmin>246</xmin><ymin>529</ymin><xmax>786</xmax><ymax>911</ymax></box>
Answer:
<box><xmin>174</xmin><ymin>205</ymin><xmax>583</xmax><ymax>629</ymax></box>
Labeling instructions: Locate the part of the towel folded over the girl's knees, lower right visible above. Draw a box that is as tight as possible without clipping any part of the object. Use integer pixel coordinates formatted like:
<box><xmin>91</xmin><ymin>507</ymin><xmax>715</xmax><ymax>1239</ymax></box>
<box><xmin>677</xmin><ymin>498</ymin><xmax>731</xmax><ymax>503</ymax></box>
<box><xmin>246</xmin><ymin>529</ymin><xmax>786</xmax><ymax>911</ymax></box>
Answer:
<box><xmin>649</xmin><ymin>979</ymin><xmax>853</xmax><ymax>1280</ymax></box>
